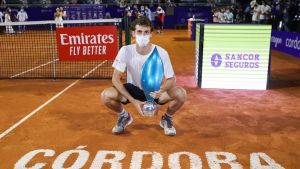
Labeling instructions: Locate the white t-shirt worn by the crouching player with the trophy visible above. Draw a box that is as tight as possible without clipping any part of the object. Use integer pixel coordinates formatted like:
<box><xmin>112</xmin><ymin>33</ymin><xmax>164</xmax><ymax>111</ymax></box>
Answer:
<box><xmin>112</xmin><ymin>44</ymin><xmax>175</xmax><ymax>89</ymax></box>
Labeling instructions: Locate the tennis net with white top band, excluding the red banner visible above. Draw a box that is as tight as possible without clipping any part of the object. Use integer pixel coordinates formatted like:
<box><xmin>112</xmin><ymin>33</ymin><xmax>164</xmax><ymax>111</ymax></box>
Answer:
<box><xmin>0</xmin><ymin>18</ymin><xmax>122</xmax><ymax>79</ymax></box>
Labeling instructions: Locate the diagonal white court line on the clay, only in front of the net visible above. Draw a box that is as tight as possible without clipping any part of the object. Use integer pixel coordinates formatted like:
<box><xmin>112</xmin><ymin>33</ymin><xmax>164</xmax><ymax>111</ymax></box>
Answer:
<box><xmin>0</xmin><ymin>80</ymin><xmax>79</xmax><ymax>140</ymax></box>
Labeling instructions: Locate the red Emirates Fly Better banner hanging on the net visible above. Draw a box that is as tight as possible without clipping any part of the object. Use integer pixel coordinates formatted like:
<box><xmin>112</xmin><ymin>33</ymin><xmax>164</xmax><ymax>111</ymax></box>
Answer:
<box><xmin>56</xmin><ymin>26</ymin><xmax>118</xmax><ymax>61</ymax></box>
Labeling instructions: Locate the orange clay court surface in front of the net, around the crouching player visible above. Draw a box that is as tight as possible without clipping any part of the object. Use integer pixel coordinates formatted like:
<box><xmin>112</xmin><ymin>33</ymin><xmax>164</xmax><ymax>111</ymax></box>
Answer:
<box><xmin>0</xmin><ymin>30</ymin><xmax>300</xmax><ymax>169</ymax></box>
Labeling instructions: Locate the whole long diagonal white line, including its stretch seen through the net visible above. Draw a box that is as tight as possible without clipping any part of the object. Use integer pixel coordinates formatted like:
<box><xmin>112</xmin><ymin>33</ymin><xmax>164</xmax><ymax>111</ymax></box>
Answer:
<box><xmin>0</xmin><ymin>60</ymin><xmax>107</xmax><ymax>140</ymax></box>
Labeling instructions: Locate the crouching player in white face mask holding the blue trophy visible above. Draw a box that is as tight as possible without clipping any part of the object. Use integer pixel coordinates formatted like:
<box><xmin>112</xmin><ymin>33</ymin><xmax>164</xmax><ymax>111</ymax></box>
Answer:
<box><xmin>101</xmin><ymin>17</ymin><xmax>186</xmax><ymax>136</ymax></box>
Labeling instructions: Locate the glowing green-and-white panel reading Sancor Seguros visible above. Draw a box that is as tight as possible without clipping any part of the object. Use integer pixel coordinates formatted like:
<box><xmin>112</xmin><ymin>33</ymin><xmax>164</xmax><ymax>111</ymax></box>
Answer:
<box><xmin>201</xmin><ymin>24</ymin><xmax>271</xmax><ymax>90</ymax></box>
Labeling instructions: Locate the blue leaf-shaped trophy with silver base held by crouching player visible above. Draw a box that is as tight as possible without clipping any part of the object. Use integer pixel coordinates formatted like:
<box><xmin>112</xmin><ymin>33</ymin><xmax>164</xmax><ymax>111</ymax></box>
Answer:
<box><xmin>141</xmin><ymin>47</ymin><xmax>164</xmax><ymax>116</ymax></box>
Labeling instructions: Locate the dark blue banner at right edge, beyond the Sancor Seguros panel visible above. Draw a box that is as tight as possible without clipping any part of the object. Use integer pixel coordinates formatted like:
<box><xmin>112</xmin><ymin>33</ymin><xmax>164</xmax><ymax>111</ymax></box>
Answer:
<box><xmin>271</xmin><ymin>30</ymin><xmax>300</xmax><ymax>58</ymax></box>
